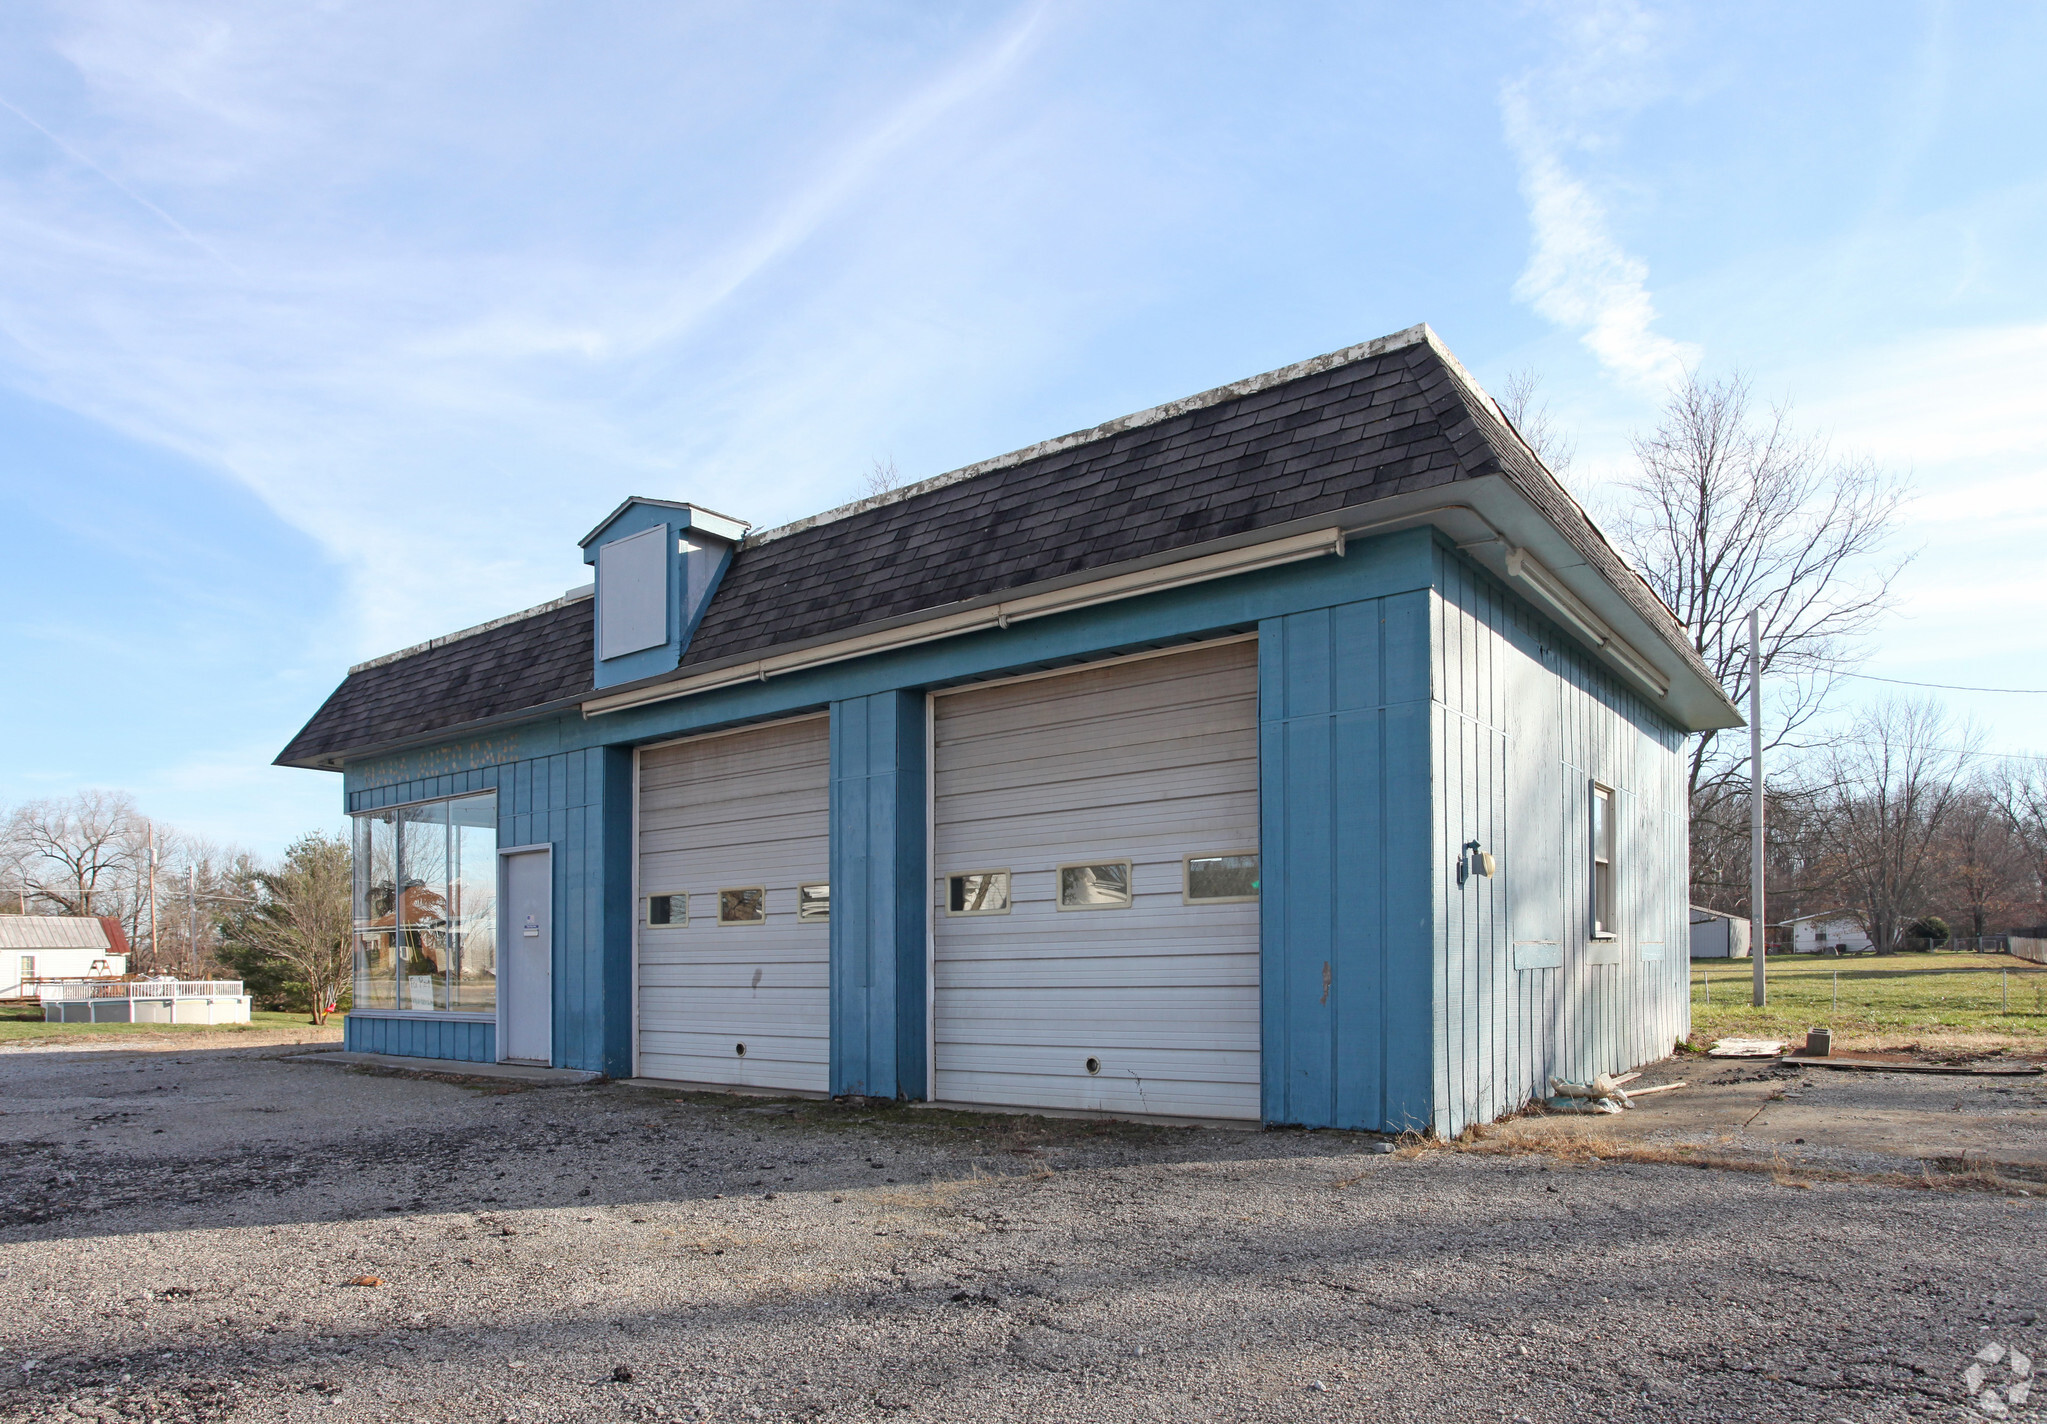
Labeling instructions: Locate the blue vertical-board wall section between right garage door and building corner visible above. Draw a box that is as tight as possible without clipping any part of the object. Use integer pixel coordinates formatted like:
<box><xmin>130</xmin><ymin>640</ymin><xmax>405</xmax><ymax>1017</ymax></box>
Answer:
<box><xmin>1259</xmin><ymin>589</ymin><xmax>1431</xmax><ymax>1131</ymax></box>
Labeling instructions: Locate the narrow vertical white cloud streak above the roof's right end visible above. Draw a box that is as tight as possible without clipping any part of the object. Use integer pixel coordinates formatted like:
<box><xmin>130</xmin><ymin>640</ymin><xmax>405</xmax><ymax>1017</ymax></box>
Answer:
<box><xmin>1500</xmin><ymin>4</ymin><xmax>1699</xmax><ymax>391</ymax></box>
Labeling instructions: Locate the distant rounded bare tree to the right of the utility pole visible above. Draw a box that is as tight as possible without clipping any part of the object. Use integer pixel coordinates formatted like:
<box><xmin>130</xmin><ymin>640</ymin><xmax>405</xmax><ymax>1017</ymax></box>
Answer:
<box><xmin>1824</xmin><ymin>700</ymin><xmax>1975</xmax><ymax>949</ymax></box>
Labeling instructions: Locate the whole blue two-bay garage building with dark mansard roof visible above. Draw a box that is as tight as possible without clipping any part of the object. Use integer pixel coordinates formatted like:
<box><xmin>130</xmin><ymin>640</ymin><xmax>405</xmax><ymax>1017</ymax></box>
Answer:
<box><xmin>278</xmin><ymin>327</ymin><xmax>1740</xmax><ymax>1133</ymax></box>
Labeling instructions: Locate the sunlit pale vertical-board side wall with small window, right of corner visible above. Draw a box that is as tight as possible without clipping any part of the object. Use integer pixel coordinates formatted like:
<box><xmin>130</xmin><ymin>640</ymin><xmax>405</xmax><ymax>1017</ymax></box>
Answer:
<box><xmin>1431</xmin><ymin>546</ymin><xmax>1691</xmax><ymax>1133</ymax></box>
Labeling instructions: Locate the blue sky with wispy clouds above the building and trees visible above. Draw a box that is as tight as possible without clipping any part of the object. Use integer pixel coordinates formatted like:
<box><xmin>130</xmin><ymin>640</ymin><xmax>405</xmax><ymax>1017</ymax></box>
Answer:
<box><xmin>0</xmin><ymin>0</ymin><xmax>2047</xmax><ymax>851</ymax></box>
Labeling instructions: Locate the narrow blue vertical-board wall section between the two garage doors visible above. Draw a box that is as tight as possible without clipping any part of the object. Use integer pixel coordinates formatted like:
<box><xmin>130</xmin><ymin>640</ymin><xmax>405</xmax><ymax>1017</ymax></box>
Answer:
<box><xmin>831</xmin><ymin>692</ymin><xmax>929</xmax><ymax>1099</ymax></box>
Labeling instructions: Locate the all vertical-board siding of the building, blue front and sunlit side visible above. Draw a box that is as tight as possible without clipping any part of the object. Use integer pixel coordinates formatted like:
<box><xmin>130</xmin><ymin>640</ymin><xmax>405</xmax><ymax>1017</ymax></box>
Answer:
<box><xmin>323</xmin><ymin>530</ymin><xmax>1689</xmax><ymax>1133</ymax></box>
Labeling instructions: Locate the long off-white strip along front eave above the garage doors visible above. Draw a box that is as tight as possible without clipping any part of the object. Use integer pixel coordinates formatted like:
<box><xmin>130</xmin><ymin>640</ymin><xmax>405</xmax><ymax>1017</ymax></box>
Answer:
<box><xmin>583</xmin><ymin>530</ymin><xmax>1343</xmax><ymax>718</ymax></box>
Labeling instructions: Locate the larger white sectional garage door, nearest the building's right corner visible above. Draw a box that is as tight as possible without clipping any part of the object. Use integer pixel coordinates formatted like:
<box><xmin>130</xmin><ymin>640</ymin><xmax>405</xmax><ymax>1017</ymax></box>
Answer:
<box><xmin>933</xmin><ymin>640</ymin><xmax>1259</xmax><ymax>1117</ymax></box>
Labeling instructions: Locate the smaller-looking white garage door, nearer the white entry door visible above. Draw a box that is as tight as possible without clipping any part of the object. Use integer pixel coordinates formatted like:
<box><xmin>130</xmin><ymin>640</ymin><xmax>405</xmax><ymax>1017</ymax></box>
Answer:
<box><xmin>639</xmin><ymin>716</ymin><xmax>831</xmax><ymax>1093</ymax></box>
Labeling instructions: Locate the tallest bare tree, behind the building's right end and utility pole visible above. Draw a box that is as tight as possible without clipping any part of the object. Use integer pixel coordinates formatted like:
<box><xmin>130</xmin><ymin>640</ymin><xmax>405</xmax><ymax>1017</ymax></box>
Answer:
<box><xmin>1609</xmin><ymin>372</ymin><xmax>1910</xmax><ymax>890</ymax></box>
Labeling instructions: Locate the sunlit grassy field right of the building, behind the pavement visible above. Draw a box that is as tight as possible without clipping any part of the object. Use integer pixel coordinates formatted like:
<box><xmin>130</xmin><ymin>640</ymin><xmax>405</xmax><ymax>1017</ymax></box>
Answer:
<box><xmin>1691</xmin><ymin>953</ymin><xmax>2047</xmax><ymax>1048</ymax></box>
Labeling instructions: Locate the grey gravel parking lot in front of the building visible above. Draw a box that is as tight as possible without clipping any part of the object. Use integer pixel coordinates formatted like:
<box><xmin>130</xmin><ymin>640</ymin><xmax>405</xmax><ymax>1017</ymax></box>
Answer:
<box><xmin>0</xmin><ymin>1043</ymin><xmax>2047</xmax><ymax>1422</ymax></box>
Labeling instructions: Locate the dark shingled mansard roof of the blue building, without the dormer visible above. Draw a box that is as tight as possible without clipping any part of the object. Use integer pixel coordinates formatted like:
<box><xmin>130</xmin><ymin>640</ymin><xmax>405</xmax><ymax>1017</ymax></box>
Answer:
<box><xmin>278</xmin><ymin>327</ymin><xmax>1705</xmax><ymax>765</ymax></box>
